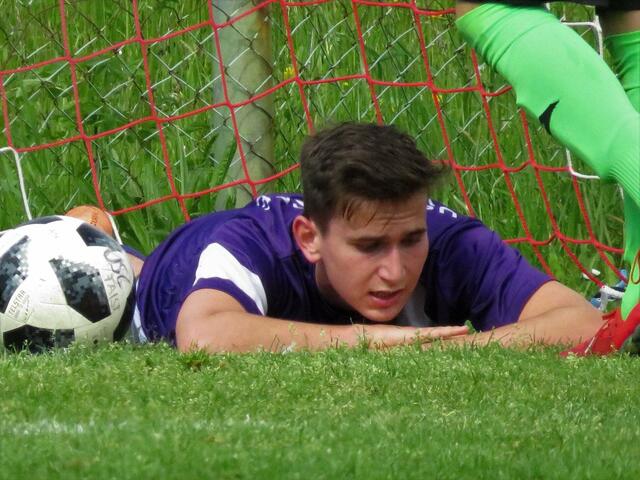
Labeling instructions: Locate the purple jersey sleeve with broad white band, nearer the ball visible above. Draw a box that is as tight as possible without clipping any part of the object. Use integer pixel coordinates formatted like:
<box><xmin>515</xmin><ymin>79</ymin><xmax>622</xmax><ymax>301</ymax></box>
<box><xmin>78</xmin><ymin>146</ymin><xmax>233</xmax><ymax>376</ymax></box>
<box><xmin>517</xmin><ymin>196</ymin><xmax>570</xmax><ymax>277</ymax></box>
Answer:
<box><xmin>187</xmin><ymin>221</ymin><xmax>277</xmax><ymax>315</ymax></box>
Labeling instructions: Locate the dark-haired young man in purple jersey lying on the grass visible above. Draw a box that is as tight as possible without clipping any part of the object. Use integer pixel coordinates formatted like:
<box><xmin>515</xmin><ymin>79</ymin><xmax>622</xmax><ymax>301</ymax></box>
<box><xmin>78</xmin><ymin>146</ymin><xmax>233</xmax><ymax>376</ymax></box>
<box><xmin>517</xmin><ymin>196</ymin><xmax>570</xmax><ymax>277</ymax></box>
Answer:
<box><xmin>114</xmin><ymin>124</ymin><xmax>620</xmax><ymax>352</ymax></box>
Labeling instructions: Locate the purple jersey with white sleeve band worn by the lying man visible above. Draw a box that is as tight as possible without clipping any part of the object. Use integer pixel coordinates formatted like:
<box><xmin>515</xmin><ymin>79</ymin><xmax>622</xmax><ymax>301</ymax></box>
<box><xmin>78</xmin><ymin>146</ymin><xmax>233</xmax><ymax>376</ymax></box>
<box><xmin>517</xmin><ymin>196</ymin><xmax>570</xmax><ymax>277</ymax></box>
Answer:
<box><xmin>137</xmin><ymin>194</ymin><xmax>550</xmax><ymax>343</ymax></box>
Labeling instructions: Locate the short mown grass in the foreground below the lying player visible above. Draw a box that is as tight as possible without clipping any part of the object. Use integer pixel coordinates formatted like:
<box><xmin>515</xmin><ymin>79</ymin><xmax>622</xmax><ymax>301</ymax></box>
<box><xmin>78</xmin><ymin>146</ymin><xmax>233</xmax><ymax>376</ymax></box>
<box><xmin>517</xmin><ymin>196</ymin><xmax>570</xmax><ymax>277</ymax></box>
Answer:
<box><xmin>0</xmin><ymin>345</ymin><xmax>640</xmax><ymax>480</ymax></box>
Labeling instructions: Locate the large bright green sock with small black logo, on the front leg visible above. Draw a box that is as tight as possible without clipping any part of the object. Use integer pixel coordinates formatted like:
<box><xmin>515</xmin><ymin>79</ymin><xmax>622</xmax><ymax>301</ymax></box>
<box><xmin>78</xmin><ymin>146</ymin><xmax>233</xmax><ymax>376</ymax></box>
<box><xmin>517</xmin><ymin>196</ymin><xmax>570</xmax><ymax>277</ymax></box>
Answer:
<box><xmin>456</xmin><ymin>3</ymin><xmax>640</xmax><ymax>318</ymax></box>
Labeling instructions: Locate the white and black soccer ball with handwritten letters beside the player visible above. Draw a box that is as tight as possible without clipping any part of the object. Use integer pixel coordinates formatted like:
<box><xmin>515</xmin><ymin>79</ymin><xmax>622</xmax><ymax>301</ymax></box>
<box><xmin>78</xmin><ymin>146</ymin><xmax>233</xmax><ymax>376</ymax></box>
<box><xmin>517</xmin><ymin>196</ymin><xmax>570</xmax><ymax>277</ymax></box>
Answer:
<box><xmin>0</xmin><ymin>216</ymin><xmax>135</xmax><ymax>352</ymax></box>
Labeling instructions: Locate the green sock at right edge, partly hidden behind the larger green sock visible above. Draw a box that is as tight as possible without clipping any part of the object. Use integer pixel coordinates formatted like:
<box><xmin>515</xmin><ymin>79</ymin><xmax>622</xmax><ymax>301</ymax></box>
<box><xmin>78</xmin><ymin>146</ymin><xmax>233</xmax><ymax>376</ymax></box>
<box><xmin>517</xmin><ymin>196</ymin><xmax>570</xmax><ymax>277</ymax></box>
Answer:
<box><xmin>605</xmin><ymin>31</ymin><xmax>640</xmax><ymax>318</ymax></box>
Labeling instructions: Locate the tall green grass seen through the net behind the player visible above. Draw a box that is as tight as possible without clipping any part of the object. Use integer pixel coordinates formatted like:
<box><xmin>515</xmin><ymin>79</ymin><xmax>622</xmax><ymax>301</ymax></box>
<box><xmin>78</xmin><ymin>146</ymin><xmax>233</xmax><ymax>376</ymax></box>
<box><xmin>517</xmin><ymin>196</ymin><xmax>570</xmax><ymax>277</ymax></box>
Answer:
<box><xmin>0</xmin><ymin>0</ymin><xmax>622</xmax><ymax>291</ymax></box>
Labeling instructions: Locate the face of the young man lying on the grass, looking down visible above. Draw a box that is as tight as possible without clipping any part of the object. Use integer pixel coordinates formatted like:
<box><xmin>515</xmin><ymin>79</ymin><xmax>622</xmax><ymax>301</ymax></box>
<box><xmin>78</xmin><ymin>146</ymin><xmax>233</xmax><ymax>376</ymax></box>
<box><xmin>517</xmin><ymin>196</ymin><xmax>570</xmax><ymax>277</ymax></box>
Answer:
<box><xmin>316</xmin><ymin>194</ymin><xmax>429</xmax><ymax>322</ymax></box>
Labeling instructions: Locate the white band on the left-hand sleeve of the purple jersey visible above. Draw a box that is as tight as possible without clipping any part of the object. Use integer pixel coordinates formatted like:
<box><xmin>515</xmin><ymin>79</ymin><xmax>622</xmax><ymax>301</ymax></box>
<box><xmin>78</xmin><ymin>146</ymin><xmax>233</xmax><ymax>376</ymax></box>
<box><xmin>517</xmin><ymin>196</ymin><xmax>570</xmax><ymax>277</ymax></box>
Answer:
<box><xmin>193</xmin><ymin>243</ymin><xmax>267</xmax><ymax>315</ymax></box>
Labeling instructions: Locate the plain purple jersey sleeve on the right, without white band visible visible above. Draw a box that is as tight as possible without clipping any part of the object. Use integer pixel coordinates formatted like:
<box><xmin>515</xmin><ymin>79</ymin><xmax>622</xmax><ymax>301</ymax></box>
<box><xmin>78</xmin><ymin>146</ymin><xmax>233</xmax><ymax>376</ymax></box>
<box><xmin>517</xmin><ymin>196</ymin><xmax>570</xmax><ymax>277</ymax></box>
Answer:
<box><xmin>424</xmin><ymin>219</ymin><xmax>552</xmax><ymax>331</ymax></box>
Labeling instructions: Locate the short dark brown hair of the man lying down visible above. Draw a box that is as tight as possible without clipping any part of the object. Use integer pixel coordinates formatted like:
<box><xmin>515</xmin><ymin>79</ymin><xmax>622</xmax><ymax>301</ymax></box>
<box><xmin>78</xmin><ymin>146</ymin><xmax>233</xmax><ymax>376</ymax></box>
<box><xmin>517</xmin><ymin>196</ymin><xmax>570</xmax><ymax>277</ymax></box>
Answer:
<box><xmin>300</xmin><ymin>123</ymin><xmax>443</xmax><ymax>230</ymax></box>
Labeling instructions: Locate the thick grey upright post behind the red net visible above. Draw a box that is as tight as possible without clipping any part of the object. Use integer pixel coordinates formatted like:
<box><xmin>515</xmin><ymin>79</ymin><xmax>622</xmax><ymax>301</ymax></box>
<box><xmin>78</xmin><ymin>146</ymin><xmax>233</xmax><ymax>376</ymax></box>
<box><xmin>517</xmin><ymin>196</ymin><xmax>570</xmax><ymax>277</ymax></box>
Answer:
<box><xmin>213</xmin><ymin>0</ymin><xmax>275</xmax><ymax>210</ymax></box>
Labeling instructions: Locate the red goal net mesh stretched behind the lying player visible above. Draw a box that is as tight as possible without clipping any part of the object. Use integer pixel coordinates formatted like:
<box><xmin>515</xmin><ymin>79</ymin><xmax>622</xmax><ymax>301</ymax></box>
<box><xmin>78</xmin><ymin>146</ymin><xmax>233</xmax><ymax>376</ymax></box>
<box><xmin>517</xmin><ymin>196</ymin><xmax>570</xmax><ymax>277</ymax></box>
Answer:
<box><xmin>0</xmin><ymin>0</ymin><xmax>621</xmax><ymax>290</ymax></box>
